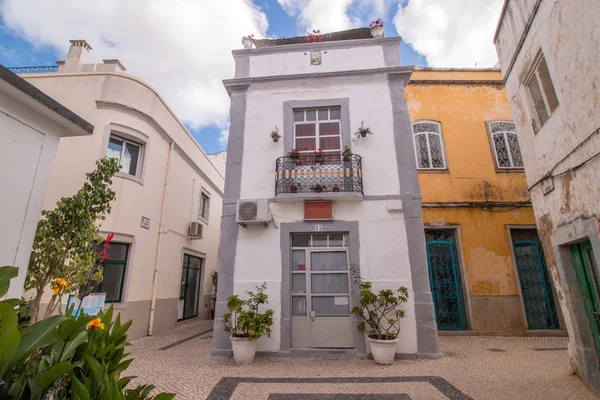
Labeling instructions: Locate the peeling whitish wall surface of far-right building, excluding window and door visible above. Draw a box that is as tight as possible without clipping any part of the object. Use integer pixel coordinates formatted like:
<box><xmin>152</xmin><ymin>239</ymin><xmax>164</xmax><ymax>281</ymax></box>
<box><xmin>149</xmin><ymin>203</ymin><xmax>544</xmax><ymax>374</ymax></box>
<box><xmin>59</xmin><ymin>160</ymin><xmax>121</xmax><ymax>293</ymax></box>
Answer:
<box><xmin>495</xmin><ymin>0</ymin><xmax>600</xmax><ymax>384</ymax></box>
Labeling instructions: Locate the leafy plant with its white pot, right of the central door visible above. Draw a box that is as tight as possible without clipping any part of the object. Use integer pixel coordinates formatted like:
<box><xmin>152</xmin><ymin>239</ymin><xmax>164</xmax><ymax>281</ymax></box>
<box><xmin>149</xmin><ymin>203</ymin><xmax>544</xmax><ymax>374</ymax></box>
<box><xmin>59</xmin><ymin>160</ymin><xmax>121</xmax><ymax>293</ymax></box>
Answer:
<box><xmin>351</xmin><ymin>267</ymin><xmax>408</xmax><ymax>365</ymax></box>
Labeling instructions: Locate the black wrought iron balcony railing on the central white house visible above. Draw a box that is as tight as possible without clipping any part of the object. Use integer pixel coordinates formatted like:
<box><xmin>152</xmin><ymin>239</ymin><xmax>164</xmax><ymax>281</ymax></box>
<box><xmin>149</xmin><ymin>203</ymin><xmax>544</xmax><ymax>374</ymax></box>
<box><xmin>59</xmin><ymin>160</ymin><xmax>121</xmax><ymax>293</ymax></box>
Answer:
<box><xmin>275</xmin><ymin>154</ymin><xmax>363</xmax><ymax>195</ymax></box>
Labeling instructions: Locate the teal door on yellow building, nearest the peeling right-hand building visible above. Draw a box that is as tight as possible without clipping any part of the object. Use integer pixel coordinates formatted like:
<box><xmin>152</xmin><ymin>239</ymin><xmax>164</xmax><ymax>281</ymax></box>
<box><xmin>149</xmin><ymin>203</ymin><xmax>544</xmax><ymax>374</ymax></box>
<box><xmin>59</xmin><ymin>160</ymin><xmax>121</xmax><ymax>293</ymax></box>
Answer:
<box><xmin>510</xmin><ymin>229</ymin><xmax>560</xmax><ymax>330</ymax></box>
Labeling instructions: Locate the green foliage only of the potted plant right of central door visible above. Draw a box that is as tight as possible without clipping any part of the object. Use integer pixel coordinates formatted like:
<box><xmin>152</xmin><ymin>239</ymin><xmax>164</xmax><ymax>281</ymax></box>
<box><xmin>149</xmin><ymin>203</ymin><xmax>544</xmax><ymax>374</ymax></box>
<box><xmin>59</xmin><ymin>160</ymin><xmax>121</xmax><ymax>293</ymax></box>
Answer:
<box><xmin>350</xmin><ymin>266</ymin><xmax>408</xmax><ymax>340</ymax></box>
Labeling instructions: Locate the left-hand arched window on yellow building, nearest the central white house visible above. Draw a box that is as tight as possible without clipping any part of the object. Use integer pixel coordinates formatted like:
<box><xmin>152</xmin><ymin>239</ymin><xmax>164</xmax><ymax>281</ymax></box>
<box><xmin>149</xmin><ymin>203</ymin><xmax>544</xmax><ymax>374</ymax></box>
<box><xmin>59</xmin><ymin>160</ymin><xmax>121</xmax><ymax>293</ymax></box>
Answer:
<box><xmin>412</xmin><ymin>121</ymin><xmax>446</xmax><ymax>169</ymax></box>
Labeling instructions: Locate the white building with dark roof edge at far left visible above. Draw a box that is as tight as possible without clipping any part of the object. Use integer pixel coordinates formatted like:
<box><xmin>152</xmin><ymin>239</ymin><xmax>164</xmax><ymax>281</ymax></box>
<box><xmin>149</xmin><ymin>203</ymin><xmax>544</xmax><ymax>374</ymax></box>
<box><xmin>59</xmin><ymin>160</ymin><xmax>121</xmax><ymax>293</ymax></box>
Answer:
<box><xmin>0</xmin><ymin>66</ymin><xmax>94</xmax><ymax>298</ymax></box>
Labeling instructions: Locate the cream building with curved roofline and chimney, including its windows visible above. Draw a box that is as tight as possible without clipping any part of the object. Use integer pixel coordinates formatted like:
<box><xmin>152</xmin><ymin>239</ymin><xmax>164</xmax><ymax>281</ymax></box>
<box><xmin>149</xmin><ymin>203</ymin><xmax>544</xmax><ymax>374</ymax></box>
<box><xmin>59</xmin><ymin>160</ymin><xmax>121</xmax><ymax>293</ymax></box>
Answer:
<box><xmin>14</xmin><ymin>41</ymin><xmax>224</xmax><ymax>338</ymax></box>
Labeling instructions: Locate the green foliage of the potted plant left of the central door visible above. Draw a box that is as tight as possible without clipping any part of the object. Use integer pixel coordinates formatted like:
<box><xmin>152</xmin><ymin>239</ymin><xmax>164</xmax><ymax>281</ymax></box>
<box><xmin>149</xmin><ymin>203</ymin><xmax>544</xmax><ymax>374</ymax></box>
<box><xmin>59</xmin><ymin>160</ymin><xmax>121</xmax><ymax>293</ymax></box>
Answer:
<box><xmin>223</xmin><ymin>282</ymin><xmax>275</xmax><ymax>340</ymax></box>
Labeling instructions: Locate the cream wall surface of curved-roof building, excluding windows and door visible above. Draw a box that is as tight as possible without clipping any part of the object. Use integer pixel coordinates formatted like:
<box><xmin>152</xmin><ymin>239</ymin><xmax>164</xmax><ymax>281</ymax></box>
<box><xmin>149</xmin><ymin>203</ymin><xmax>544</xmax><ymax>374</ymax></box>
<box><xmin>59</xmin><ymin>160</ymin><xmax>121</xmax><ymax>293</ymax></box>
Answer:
<box><xmin>26</xmin><ymin>73</ymin><xmax>224</xmax><ymax>337</ymax></box>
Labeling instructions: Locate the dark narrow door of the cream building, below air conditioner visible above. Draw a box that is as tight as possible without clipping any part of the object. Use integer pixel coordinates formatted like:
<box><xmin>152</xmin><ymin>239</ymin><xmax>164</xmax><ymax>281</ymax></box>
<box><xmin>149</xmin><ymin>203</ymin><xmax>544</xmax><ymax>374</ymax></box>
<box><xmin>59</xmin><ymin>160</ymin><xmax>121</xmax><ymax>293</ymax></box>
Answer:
<box><xmin>177</xmin><ymin>254</ymin><xmax>202</xmax><ymax>321</ymax></box>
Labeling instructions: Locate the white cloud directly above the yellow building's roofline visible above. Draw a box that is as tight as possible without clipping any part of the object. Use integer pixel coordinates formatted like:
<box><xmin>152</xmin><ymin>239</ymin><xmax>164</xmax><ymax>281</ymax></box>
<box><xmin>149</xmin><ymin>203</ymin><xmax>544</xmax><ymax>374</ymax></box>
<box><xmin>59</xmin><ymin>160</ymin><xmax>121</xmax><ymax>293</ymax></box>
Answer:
<box><xmin>394</xmin><ymin>0</ymin><xmax>503</xmax><ymax>68</ymax></box>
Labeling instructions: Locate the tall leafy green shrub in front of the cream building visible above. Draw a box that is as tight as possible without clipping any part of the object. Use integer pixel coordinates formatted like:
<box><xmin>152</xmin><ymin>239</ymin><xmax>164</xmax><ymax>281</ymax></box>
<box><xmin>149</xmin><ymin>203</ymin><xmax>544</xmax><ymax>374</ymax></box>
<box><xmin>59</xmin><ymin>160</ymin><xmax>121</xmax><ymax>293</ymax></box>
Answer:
<box><xmin>25</xmin><ymin>157</ymin><xmax>121</xmax><ymax>320</ymax></box>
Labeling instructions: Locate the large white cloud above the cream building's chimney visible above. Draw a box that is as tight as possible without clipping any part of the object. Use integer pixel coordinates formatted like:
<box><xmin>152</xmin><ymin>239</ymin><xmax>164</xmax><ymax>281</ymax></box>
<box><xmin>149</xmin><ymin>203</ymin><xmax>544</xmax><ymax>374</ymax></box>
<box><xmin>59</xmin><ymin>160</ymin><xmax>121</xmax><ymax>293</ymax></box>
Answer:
<box><xmin>0</xmin><ymin>0</ymin><xmax>268</xmax><ymax>129</ymax></box>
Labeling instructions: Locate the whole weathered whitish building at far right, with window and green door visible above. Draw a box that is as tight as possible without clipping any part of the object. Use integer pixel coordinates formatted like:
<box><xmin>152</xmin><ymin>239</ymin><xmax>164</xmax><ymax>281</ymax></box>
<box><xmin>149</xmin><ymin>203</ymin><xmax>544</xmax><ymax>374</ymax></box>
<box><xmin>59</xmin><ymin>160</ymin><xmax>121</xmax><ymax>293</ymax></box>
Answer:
<box><xmin>494</xmin><ymin>0</ymin><xmax>600</xmax><ymax>393</ymax></box>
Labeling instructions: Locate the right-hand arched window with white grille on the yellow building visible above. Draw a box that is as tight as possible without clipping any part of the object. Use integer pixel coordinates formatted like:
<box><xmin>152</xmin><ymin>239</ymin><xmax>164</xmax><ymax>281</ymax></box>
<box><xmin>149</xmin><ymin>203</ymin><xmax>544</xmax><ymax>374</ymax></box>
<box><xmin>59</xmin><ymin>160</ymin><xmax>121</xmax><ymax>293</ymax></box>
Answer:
<box><xmin>488</xmin><ymin>121</ymin><xmax>523</xmax><ymax>169</ymax></box>
